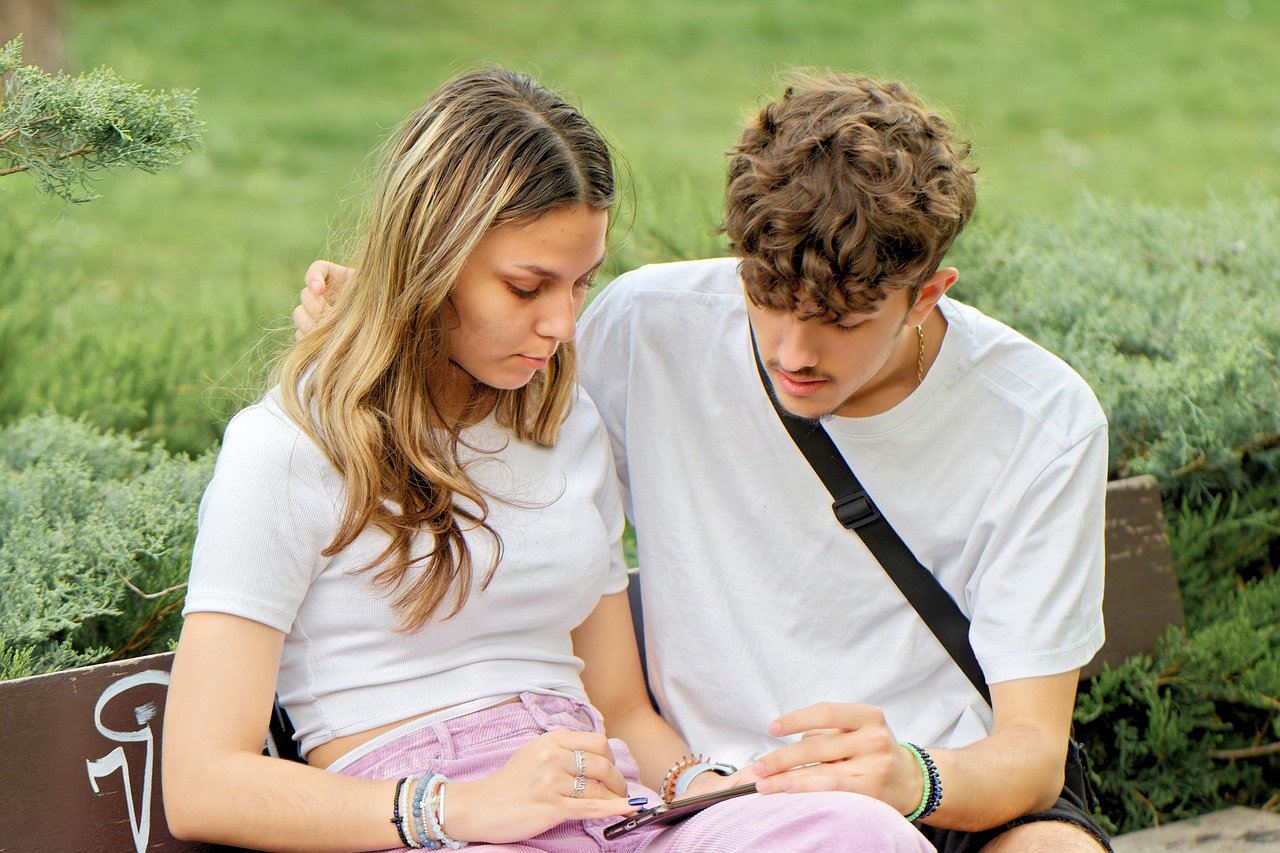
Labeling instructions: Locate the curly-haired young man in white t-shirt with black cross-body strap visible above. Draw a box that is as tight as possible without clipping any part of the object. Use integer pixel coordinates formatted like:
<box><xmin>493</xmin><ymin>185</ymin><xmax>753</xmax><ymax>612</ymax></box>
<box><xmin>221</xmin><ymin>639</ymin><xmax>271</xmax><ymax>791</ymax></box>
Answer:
<box><xmin>294</xmin><ymin>76</ymin><xmax>1107</xmax><ymax>850</ymax></box>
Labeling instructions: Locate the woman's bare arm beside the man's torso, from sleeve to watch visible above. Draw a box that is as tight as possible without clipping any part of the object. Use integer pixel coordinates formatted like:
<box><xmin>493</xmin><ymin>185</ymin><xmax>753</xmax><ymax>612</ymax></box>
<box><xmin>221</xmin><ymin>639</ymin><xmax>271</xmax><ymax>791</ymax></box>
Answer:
<box><xmin>573</xmin><ymin>592</ymin><xmax>689</xmax><ymax>790</ymax></box>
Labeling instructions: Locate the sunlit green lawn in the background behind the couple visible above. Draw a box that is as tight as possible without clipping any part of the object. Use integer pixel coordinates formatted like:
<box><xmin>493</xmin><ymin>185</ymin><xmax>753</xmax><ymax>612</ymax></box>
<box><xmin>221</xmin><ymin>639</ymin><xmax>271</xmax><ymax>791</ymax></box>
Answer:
<box><xmin>0</xmin><ymin>0</ymin><xmax>1280</xmax><ymax>450</ymax></box>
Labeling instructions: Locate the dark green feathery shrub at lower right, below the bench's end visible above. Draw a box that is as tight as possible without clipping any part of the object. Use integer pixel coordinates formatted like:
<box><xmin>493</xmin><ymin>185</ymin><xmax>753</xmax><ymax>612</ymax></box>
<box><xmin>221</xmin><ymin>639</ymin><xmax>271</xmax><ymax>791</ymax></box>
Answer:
<box><xmin>1075</xmin><ymin>574</ymin><xmax>1280</xmax><ymax>831</ymax></box>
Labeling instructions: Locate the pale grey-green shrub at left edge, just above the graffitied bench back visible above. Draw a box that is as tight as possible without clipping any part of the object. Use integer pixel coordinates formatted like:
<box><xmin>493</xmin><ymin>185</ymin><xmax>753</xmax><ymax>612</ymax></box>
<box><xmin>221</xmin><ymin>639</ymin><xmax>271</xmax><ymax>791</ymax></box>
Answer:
<box><xmin>0</xmin><ymin>415</ymin><xmax>212</xmax><ymax>678</ymax></box>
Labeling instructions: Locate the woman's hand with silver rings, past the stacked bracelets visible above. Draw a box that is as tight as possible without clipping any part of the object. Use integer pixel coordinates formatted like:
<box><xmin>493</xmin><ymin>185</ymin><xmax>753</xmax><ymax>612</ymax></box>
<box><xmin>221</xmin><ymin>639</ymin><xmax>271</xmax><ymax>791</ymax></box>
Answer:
<box><xmin>444</xmin><ymin>729</ymin><xmax>639</xmax><ymax>844</ymax></box>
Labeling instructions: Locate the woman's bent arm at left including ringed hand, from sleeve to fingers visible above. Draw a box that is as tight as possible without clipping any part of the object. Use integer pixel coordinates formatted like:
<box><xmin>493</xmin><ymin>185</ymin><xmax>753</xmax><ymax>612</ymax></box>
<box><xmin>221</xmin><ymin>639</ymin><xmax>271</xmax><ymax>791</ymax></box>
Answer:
<box><xmin>163</xmin><ymin>612</ymin><xmax>635</xmax><ymax>850</ymax></box>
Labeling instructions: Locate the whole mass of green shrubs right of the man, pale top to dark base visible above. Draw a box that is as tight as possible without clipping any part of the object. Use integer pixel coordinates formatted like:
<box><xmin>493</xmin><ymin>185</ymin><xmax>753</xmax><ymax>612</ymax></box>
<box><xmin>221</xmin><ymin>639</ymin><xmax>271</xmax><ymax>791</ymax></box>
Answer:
<box><xmin>952</xmin><ymin>193</ymin><xmax>1280</xmax><ymax>830</ymax></box>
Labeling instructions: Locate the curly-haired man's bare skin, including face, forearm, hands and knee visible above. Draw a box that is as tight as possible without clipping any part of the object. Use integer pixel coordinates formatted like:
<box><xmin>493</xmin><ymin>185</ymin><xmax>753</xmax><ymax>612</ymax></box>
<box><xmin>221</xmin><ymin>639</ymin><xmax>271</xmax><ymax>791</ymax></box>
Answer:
<box><xmin>294</xmin><ymin>261</ymin><xmax>1102</xmax><ymax>853</ymax></box>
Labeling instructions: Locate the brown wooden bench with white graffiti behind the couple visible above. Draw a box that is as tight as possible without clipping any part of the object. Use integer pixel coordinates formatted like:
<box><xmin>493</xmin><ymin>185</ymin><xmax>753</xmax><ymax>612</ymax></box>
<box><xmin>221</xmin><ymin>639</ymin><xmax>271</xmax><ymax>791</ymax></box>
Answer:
<box><xmin>0</xmin><ymin>478</ymin><xmax>1183</xmax><ymax>853</ymax></box>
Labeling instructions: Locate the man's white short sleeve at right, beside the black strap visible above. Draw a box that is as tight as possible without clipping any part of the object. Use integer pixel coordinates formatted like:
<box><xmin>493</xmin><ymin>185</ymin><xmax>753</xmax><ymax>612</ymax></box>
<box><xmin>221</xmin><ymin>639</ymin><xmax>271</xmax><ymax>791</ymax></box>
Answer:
<box><xmin>968</xmin><ymin>425</ymin><xmax>1107</xmax><ymax>683</ymax></box>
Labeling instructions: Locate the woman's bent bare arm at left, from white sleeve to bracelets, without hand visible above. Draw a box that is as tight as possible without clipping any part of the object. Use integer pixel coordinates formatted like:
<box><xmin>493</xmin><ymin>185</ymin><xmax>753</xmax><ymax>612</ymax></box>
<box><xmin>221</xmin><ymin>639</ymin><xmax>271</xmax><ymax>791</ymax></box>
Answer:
<box><xmin>163</xmin><ymin>612</ymin><xmax>399</xmax><ymax>850</ymax></box>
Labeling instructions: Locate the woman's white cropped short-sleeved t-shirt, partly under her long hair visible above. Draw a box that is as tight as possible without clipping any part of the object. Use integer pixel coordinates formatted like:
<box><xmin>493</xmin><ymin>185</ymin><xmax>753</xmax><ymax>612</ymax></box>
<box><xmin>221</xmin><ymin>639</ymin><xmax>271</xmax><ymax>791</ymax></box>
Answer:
<box><xmin>183</xmin><ymin>392</ymin><xmax>627</xmax><ymax>753</ymax></box>
